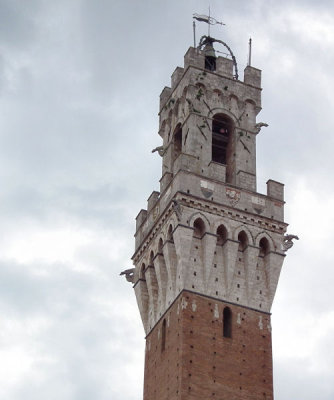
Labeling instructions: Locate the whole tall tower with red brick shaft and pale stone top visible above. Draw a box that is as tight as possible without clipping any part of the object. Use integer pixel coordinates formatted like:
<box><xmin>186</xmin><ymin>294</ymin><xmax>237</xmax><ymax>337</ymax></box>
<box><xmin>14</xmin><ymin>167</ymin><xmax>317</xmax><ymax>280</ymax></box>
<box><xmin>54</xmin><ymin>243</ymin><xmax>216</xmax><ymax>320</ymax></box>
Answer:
<box><xmin>124</xmin><ymin>33</ymin><xmax>292</xmax><ymax>400</ymax></box>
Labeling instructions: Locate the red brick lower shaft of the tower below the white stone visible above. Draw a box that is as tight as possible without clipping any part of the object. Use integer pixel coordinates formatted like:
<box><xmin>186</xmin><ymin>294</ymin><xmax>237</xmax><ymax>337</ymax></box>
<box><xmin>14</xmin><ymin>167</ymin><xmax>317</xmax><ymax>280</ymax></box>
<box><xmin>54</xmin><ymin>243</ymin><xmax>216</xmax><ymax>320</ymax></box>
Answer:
<box><xmin>144</xmin><ymin>292</ymin><xmax>273</xmax><ymax>400</ymax></box>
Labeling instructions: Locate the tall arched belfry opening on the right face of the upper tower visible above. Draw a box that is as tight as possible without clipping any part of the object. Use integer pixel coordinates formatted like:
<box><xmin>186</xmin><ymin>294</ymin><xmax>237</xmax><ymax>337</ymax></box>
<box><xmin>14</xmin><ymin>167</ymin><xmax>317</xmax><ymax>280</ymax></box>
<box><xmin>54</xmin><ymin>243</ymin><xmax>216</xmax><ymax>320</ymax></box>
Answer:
<box><xmin>212</xmin><ymin>114</ymin><xmax>233</xmax><ymax>165</ymax></box>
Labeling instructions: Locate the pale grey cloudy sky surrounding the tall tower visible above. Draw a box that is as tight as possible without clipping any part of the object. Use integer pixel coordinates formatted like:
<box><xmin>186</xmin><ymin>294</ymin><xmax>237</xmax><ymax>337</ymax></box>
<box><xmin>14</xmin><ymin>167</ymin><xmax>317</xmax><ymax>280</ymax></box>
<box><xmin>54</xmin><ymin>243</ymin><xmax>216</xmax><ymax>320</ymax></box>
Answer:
<box><xmin>0</xmin><ymin>0</ymin><xmax>334</xmax><ymax>400</ymax></box>
